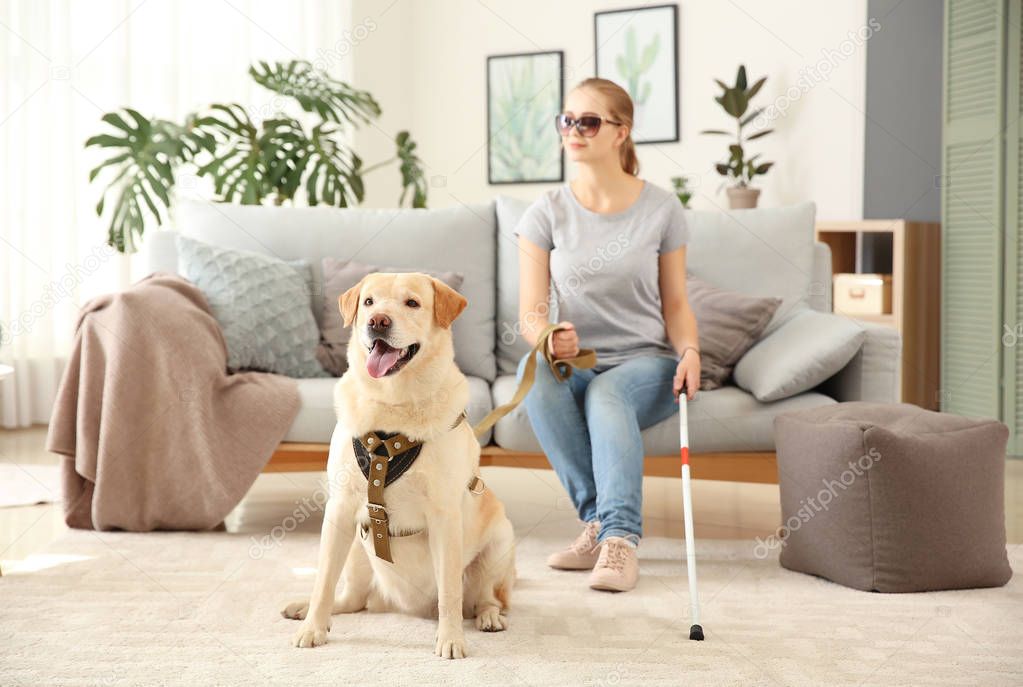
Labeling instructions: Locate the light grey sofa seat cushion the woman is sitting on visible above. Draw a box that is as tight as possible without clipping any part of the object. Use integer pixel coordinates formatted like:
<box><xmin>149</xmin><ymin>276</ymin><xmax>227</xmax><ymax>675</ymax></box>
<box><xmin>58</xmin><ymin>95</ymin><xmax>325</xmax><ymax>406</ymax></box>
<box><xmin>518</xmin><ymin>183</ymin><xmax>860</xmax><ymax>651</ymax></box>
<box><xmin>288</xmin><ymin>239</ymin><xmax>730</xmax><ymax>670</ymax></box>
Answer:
<box><xmin>492</xmin><ymin>374</ymin><xmax>835</xmax><ymax>456</ymax></box>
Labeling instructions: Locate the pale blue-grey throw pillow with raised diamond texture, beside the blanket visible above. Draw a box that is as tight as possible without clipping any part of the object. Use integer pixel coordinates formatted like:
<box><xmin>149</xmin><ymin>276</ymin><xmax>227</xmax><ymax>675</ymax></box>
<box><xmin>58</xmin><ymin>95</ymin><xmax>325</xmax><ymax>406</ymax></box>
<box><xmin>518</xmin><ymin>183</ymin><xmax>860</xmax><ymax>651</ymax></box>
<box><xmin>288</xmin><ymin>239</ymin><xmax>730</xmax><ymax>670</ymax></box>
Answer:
<box><xmin>177</xmin><ymin>235</ymin><xmax>329</xmax><ymax>377</ymax></box>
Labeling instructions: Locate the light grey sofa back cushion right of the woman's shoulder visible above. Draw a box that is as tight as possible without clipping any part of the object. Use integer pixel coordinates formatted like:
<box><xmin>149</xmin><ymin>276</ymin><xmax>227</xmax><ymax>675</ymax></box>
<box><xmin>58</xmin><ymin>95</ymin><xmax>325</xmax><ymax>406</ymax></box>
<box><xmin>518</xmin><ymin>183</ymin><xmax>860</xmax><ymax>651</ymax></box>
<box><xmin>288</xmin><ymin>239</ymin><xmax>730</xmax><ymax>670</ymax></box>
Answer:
<box><xmin>685</xmin><ymin>202</ymin><xmax>820</xmax><ymax>335</ymax></box>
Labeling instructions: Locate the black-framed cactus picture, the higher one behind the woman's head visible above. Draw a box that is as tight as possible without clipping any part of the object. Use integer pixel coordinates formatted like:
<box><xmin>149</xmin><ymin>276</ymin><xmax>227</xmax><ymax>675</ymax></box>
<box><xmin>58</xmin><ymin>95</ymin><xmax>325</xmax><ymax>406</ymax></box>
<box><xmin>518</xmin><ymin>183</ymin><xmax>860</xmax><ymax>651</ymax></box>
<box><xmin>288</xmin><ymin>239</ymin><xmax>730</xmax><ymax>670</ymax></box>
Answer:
<box><xmin>593</xmin><ymin>5</ymin><xmax>678</xmax><ymax>143</ymax></box>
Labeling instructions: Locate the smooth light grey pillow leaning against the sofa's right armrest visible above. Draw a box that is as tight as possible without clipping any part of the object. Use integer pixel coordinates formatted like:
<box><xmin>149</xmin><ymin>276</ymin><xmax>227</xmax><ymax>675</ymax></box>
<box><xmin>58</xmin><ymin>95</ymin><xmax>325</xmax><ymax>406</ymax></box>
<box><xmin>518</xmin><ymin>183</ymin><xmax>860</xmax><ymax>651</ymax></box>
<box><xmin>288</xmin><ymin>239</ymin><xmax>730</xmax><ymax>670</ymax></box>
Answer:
<box><xmin>733</xmin><ymin>309</ymin><xmax>866</xmax><ymax>401</ymax></box>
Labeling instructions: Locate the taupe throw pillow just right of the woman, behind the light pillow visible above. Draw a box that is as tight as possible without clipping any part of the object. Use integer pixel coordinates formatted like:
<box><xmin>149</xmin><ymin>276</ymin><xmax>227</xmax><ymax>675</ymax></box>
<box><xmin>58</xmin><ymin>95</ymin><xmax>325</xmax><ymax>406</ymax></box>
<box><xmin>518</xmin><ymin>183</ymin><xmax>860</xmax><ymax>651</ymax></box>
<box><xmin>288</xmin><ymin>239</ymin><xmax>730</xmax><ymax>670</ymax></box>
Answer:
<box><xmin>685</xmin><ymin>275</ymin><xmax>782</xmax><ymax>391</ymax></box>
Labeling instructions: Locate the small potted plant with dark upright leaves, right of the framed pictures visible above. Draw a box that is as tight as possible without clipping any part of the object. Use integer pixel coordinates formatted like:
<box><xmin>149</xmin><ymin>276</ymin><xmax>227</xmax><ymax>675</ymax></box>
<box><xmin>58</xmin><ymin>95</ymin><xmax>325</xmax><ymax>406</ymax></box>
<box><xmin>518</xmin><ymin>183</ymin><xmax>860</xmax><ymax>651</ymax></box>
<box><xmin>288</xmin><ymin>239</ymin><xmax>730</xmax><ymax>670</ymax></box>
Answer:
<box><xmin>701</xmin><ymin>64</ymin><xmax>774</xmax><ymax>210</ymax></box>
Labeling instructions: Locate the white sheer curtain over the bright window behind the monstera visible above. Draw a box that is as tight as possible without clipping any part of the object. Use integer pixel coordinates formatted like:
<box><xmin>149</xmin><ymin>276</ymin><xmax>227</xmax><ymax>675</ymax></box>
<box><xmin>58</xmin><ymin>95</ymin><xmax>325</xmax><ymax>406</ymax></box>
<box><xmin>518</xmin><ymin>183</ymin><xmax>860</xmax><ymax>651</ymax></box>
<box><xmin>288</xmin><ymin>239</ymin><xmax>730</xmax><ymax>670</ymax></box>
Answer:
<box><xmin>0</xmin><ymin>0</ymin><xmax>351</xmax><ymax>428</ymax></box>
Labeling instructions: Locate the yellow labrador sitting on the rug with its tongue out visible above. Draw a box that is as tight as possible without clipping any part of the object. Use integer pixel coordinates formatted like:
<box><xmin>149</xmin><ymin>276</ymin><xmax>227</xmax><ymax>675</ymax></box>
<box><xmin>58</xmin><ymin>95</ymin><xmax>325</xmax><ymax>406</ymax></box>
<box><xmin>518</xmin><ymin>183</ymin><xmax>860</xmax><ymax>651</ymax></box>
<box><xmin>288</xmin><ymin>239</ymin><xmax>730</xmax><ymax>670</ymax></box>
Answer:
<box><xmin>281</xmin><ymin>272</ymin><xmax>516</xmax><ymax>658</ymax></box>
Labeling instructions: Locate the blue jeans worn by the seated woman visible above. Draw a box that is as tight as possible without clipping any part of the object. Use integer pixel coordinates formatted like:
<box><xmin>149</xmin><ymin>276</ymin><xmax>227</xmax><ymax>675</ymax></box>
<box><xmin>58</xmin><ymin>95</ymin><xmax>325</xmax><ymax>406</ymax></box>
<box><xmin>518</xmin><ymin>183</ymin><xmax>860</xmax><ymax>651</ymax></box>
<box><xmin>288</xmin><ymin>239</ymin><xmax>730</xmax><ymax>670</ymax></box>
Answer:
<box><xmin>517</xmin><ymin>352</ymin><xmax>678</xmax><ymax>544</ymax></box>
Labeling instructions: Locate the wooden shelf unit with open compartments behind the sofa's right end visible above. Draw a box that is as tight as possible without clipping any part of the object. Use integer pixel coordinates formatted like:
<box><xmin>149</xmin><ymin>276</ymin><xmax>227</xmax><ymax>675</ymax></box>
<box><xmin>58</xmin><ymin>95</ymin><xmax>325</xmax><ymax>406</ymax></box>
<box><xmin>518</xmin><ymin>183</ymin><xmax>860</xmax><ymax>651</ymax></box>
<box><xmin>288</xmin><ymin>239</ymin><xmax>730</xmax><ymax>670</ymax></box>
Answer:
<box><xmin>815</xmin><ymin>220</ymin><xmax>941</xmax><ymax>410</ymax></box>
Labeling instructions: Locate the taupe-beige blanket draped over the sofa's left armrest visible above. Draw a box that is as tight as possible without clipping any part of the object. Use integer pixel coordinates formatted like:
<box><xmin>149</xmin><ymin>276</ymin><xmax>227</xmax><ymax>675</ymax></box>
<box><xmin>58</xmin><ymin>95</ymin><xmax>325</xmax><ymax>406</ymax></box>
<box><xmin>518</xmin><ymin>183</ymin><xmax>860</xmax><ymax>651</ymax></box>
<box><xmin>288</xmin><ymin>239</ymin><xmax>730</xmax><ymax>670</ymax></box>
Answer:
<box><xmin>47</xmin><ymin>273</ymin><xmax>299</xmax><ymax>532</ymax></box>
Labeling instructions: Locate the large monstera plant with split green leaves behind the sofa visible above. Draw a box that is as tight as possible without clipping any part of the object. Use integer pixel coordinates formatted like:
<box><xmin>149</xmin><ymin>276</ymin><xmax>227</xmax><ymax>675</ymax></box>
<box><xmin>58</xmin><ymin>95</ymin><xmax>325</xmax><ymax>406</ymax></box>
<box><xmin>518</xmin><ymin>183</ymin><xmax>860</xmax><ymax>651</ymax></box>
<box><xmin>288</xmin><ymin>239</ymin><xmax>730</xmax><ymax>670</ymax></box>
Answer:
<box><xmin>85</xmin><ymin>60</ymin><xmax>427</xmax><ymax>253</ymax></box>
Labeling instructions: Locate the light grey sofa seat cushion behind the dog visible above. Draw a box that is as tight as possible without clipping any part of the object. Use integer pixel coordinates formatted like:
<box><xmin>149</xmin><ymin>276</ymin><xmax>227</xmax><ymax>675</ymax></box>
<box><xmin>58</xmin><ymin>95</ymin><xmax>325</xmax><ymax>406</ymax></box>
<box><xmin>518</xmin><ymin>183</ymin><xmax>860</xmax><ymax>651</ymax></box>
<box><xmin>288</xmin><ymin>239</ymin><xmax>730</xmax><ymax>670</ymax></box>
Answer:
<box><xmin>283</xmin><ymin>375</ymin><xmax>493</xmax><ymax>445</ymax></box>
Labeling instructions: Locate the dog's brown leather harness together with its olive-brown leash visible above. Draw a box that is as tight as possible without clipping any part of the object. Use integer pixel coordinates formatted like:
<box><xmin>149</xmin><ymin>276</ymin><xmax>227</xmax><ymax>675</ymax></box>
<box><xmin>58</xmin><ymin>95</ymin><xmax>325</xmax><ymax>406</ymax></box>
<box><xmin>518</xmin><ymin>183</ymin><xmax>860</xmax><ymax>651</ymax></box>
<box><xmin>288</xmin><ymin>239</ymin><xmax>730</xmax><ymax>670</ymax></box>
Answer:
<box><xmin>352</xmin><ymin>323</ymin><xmax>596</xmax><ymax>563</ymax></box>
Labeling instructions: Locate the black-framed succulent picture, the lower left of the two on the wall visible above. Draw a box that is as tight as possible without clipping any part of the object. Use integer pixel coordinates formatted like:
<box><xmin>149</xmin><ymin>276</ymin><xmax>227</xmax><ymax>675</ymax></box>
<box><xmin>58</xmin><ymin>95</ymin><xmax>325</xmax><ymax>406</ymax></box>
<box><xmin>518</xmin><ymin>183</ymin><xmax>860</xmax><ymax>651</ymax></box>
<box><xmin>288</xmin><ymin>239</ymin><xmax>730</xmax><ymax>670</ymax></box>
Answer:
<box><xmin>487</xmin><ymin>50</ymin><xmax>565</xmax><ymax>184</ymax></box>
